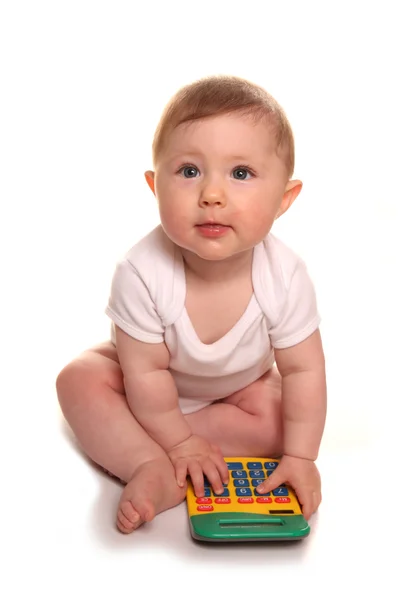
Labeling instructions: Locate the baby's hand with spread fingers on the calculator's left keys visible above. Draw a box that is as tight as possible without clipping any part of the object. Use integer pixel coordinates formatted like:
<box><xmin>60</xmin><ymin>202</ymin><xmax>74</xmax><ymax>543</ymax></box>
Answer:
<box><xmin>168</xmin><ymin>435</ymin><xmax>229</xmax><ymax>497</ymax></box>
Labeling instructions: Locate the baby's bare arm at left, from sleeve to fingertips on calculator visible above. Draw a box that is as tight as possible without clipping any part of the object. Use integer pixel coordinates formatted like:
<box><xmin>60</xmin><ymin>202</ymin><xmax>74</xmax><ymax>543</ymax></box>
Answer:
<box><xmin>115</xmin><ymin>326</ymin><xmax>228</xmax><ymax>495</ymax></box>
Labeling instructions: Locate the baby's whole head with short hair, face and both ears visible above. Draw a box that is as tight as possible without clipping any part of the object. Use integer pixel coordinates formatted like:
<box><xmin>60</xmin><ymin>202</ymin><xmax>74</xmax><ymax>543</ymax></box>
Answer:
<box><xmin>146</xmin><ymin>76</ymin><xmax>302</xmax><ymax>260</ymax></box>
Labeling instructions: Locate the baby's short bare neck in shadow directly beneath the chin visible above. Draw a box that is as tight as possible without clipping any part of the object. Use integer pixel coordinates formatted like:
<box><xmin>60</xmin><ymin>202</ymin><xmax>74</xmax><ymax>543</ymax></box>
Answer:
<box><xmin>181</xmin><ymin>249</ymin><xmax>254</xmax><ymax>283</ymax></box>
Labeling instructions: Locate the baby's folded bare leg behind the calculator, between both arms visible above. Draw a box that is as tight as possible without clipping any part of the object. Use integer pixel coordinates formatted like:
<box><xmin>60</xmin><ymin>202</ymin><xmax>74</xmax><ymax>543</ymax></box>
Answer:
<box><xmin>186</xmin><ymin>367</ymin><xmax>282</xmax><ymax>457</ymax></box>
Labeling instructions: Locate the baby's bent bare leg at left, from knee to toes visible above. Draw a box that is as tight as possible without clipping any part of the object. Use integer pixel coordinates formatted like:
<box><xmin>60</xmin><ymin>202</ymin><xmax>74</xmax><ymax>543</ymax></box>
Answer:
<box><xmin>56</xmin><ymin>343</ymin><xmax>185</xmax><ymax>533</ymax></box>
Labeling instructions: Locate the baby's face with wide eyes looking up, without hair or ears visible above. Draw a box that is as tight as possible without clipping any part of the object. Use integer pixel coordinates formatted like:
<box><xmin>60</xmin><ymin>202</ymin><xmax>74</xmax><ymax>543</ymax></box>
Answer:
<box><xmin>151</xmin><ymin>114</ymin><xmax>298</xmax><ymax>260</ymax></box>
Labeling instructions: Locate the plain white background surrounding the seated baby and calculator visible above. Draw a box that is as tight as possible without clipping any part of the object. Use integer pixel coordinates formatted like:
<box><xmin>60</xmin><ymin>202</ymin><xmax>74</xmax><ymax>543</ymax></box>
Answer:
<box><xmin>0</xmin><ymin>0</ymin><xmax>415</xmax><ymax>599</ymax></box>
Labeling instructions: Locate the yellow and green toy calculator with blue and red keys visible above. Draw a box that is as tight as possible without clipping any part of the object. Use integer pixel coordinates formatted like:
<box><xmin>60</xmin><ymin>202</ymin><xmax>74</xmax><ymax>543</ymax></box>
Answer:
<box><xmin>187</xmin><ymin>457</ymin><xmax>310</xmax><ymax>542</ymax></box>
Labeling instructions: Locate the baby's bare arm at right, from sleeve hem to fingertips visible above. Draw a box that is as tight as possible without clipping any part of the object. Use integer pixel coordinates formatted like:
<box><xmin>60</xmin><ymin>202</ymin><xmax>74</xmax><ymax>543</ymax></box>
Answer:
<box><xmin>258</xmin><ymin>330</ymin><xmax>327</xmax><ymax>519</ymax></box>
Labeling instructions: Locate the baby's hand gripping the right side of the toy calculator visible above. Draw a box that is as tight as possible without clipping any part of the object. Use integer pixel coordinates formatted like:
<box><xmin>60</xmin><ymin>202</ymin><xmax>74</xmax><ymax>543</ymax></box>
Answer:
<box><xmin>257</xmin><ymin>455</ymin><xmax>321</xmax><ymax>520</ymax></box>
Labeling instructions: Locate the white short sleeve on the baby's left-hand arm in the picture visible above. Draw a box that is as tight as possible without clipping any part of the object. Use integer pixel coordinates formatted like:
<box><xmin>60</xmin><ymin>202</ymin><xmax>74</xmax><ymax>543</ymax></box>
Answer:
<box><xmin>105</xmin><ymin>259</ymin><xmax>164</xmax><ymax>344</ymax></box>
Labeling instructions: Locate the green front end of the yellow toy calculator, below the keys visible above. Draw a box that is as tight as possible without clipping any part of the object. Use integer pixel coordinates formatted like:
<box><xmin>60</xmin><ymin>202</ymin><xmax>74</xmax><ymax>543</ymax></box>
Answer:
<box><xmin>190</xmin><ymin>512</ymin><xmax>310</xmax><ymax>542</ymax></box>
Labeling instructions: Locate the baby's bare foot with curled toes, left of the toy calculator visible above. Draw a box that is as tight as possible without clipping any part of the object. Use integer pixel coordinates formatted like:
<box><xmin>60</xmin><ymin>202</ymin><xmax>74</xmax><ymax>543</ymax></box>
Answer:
<box><xmin>117</xmin><ymin>456</ymin><xmax>186</xmax><ymax>533</ymax></box>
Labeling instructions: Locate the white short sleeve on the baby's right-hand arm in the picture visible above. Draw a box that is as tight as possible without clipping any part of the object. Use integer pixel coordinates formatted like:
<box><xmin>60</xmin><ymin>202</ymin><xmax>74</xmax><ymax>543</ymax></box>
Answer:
<box><xmin>269</xmin><ymin>259</ymin><xmax>321</xmax><ymax>349</ymax></box>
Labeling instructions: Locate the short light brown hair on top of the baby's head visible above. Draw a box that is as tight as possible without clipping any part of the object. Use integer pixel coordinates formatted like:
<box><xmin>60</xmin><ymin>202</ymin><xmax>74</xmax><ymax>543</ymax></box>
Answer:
<box><xmin>153</xmin><ymin>75</ymin><xmax>294</xmax><ymax>178</ymax></box>
